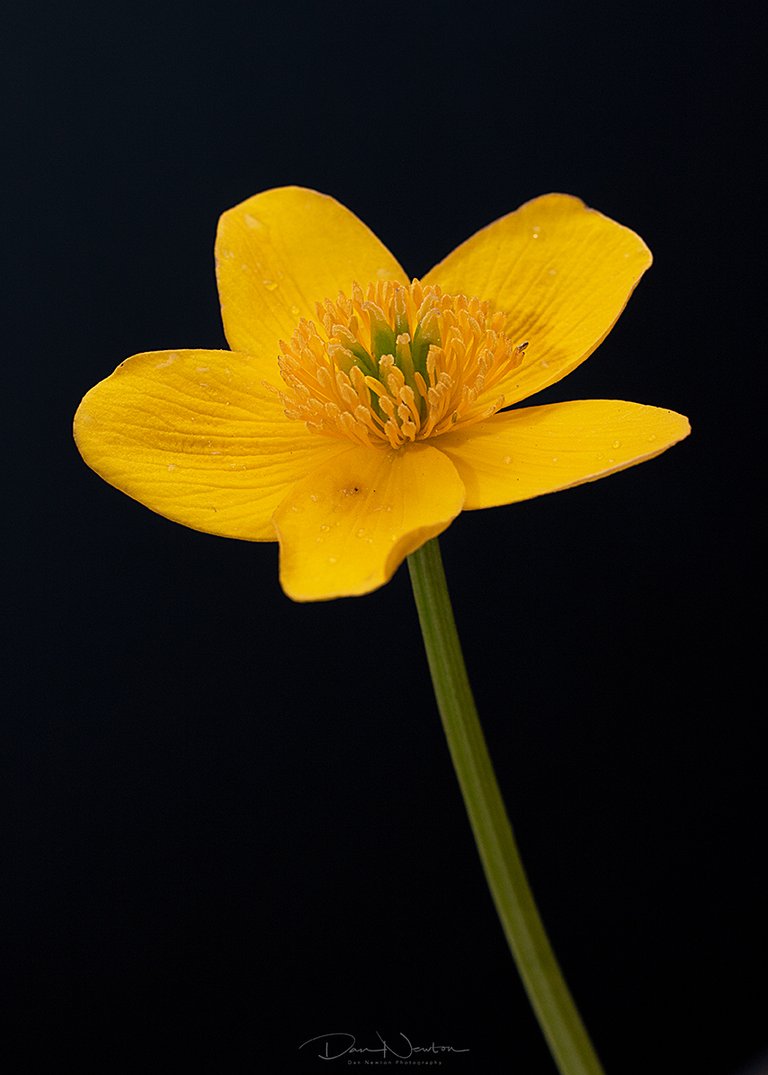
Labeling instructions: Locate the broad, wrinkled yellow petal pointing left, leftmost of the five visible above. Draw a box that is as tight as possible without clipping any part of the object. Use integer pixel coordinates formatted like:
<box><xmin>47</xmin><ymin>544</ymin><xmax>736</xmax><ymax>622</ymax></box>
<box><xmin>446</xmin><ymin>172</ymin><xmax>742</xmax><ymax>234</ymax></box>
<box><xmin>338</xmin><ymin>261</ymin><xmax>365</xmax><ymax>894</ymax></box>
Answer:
<box><xmin>74</xmin><ymin>350</ymin><xmax>345</xmax><ymax>541</ymax></box>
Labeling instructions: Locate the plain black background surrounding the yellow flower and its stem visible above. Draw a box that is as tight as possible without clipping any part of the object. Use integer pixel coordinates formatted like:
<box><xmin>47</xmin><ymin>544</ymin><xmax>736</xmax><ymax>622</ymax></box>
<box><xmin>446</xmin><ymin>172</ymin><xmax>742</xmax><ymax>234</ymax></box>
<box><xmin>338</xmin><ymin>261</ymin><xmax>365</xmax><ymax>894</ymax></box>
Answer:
<box><xmin>2</xmin><ymin>0</ymin><xmax>768</xmax><ymax>1075</ymax></box>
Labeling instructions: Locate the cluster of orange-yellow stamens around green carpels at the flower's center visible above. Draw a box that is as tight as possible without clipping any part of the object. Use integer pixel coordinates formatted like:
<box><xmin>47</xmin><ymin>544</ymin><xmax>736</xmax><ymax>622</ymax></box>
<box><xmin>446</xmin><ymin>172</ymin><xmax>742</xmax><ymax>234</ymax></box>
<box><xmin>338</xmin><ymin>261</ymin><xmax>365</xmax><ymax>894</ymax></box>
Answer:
<box><xmin>279</xmin><ymin>281</ymin><xmax>527</xmax><ymax>448</ymax></box>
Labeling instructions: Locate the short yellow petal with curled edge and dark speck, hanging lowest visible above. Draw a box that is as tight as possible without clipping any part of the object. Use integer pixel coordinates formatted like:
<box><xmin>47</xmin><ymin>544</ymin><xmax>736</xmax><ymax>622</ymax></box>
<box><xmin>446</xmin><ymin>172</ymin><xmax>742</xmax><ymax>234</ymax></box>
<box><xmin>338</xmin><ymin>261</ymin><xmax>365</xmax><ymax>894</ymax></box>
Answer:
<box><xmin>274</xmin><ymin>444</ymin><xmax>464</xmax><ymax>601</ymax></box>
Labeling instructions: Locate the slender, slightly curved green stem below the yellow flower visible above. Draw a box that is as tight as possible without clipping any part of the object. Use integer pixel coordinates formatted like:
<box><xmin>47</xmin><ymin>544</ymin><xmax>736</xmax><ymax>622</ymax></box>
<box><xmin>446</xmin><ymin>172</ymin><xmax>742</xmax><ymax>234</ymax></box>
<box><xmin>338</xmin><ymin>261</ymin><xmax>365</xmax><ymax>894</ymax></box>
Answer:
<box><xmin>408</xmin><ymin>538</ymin><xmax>602</xmax><ymax>1075</ymax></box>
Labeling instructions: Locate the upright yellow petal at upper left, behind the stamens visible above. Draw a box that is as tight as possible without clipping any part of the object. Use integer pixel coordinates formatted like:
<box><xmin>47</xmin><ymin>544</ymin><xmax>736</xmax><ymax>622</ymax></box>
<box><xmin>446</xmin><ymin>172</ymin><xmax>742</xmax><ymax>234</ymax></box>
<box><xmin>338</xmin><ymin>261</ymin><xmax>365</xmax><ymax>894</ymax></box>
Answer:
<box><xmin>211</xmin><ymin>187</ymin><xmax>408</xmax><ymax>358</ymax></box>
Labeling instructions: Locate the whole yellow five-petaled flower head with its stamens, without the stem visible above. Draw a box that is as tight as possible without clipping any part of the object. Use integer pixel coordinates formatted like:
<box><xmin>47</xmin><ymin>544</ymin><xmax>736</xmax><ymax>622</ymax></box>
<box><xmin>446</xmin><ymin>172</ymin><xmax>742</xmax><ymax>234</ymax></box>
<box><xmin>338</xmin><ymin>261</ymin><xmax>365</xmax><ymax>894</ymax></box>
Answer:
<box><xmin>75</xmin><ymin>187</ymin><xmax>689</xmax><ymax>601</ymax></box>
